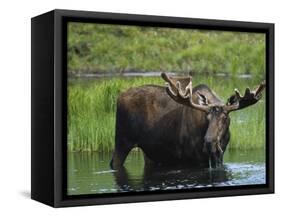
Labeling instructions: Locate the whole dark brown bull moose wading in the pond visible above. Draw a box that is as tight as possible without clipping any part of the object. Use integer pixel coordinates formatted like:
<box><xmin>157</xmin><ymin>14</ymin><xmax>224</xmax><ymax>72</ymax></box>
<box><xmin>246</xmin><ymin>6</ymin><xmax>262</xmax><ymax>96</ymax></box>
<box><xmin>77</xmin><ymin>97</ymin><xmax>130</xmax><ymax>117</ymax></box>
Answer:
<box><xmin>110</xmin><ymin>73</ymin><xmax>265</xmax><ymax>169</ymax></box>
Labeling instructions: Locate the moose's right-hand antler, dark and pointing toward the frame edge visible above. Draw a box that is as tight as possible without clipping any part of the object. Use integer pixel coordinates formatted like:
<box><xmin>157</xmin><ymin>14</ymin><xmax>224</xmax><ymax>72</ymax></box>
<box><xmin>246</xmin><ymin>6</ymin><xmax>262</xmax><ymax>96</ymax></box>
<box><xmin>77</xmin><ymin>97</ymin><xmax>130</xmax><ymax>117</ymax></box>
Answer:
<box><xmin>225</xmin><ymin>81</ymin><xmax>265</xmax><ymax>112</ymax></box>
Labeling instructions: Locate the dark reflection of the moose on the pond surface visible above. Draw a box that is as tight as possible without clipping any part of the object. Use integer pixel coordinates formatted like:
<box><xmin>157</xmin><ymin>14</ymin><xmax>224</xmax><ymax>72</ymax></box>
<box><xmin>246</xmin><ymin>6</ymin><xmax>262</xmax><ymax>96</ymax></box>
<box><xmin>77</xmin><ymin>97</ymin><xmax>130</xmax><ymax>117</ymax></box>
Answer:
<box><xmin>113</xmin><ymin>166</ymin><xmax>232</xmax><ymax>192</ymax></box>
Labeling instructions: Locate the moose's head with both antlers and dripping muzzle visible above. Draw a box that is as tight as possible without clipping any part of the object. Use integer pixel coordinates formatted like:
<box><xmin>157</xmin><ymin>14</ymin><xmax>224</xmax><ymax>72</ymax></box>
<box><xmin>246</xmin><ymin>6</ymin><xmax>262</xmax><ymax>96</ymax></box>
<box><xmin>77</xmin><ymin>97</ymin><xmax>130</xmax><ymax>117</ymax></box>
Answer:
<box><xmin>161</xmin><ymin>73</ymin><xmax>265</xmax><ymax>167</ymax></box>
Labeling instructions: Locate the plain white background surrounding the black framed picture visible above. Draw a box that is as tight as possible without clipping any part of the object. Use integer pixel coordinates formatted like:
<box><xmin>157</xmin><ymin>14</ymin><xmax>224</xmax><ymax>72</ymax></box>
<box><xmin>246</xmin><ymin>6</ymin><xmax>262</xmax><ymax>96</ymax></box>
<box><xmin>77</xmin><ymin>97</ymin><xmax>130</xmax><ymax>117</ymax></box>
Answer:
<box><xmin>0</xmin><ymin>0</ymin><xmax>281</xmax><ymax>217</ymax></box>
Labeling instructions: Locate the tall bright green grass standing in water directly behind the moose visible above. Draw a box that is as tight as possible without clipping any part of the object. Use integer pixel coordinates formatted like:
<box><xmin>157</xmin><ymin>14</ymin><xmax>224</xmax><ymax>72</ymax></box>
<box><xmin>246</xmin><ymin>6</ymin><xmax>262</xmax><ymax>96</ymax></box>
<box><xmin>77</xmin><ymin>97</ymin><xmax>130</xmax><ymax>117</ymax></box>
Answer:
<box><xmin>68</xmin><ymin>76</ymin><xmax>265</xmax><ymax>152</ymax></box>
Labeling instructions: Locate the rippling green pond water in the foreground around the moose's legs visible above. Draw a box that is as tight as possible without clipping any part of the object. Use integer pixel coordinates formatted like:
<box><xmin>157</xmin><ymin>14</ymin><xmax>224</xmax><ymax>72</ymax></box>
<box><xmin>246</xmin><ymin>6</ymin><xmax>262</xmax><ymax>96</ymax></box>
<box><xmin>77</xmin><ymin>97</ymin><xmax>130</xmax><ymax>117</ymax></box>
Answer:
<box><xmin>67</xmin><ymin>149</ymin><xmax>266</xmax><ymax>195</ymax></box>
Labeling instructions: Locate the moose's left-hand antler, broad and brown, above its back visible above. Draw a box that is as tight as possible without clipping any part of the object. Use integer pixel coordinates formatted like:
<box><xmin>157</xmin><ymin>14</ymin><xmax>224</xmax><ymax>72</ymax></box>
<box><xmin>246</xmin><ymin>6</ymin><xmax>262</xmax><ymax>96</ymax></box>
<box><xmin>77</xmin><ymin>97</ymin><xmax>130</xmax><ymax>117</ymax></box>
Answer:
<box><xmin>161</xmin><ymin>73</ymin><xmax>209</xmax><ymax>112</ymax></box>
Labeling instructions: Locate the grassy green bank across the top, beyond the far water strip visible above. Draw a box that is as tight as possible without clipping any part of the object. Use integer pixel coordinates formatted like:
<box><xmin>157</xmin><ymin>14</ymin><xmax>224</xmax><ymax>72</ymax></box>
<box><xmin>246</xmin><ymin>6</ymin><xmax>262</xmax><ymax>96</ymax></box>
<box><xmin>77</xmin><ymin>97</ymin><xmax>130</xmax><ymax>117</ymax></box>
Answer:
<box><xmin>68</xmin><ymin>23</ymin><xmax>265</xmax><ymax>76</ymax></box>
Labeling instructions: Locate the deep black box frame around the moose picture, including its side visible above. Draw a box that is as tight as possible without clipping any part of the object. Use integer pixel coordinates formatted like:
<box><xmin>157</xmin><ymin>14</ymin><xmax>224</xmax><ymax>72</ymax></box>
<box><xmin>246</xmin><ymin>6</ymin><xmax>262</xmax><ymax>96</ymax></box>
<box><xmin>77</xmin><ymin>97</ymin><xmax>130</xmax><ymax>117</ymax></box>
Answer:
<box><xmin>31</xmin><ymin>10</ymin><xmax>274</xmax><ymax>207</ymax></box>
